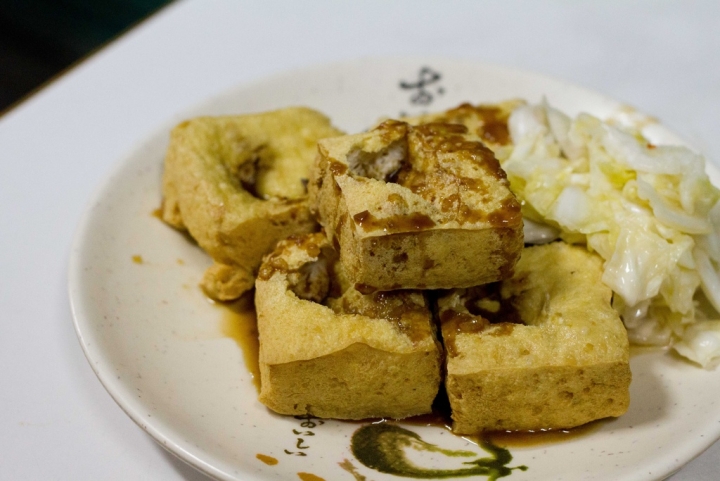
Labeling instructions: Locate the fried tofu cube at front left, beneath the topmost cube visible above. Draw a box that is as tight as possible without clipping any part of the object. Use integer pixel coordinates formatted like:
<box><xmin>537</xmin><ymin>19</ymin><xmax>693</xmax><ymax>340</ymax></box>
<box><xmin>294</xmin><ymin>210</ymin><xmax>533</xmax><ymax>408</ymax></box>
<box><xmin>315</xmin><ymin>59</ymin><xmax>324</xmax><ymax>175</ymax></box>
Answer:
<box><xmin>255</xmin><ymin>233</ymin><xmax>442</xmax><ymax>419</ymax></box>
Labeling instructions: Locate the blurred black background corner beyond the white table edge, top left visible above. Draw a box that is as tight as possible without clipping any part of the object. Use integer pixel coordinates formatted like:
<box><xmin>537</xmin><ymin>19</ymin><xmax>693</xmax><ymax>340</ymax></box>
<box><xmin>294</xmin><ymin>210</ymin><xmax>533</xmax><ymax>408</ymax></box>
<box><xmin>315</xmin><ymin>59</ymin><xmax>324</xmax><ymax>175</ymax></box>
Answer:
<box><xmin>0</xmin><ymin>0</ymin><xmax>170</xmax><ymax>112</ymax></box>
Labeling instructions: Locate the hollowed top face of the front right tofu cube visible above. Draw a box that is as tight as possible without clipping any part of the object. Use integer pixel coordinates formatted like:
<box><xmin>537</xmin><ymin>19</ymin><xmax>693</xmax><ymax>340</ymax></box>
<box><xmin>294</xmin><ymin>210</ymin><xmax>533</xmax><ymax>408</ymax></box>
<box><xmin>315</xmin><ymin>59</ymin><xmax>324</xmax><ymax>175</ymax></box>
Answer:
<box><xmin>437</xmin><ymin>242</ymin><xmax>628</xmax><ymax>366</ymax></box>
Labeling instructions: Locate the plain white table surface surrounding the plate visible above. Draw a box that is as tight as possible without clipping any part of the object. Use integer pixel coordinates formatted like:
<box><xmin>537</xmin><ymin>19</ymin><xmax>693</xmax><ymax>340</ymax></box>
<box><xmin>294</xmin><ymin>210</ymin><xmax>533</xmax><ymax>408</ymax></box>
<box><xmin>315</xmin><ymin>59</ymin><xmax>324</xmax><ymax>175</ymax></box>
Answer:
<box><xmin>0</xmin><ymin>0</ymin><xmax>720</xmax><ymax>481</ymax></box>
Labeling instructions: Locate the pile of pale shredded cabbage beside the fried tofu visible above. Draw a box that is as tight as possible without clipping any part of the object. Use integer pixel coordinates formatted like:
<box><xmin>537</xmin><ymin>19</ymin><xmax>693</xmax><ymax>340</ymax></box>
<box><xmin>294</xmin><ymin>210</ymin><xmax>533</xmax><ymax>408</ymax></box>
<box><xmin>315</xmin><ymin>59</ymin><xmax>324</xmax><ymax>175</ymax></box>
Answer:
<box><xmin>500</xmin><ymin>102</ymin><xmax>720</xmax><ymax>366</ymax></box>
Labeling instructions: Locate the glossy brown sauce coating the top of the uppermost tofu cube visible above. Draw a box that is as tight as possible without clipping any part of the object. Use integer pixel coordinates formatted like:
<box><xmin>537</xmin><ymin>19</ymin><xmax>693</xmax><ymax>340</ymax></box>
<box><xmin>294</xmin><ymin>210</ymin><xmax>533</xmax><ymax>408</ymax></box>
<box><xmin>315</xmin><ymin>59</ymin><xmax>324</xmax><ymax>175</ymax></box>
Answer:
<box><xmin>334</xmin><ymin>118</ymin><xmax>522</xmax><ymax>234</ymax></box>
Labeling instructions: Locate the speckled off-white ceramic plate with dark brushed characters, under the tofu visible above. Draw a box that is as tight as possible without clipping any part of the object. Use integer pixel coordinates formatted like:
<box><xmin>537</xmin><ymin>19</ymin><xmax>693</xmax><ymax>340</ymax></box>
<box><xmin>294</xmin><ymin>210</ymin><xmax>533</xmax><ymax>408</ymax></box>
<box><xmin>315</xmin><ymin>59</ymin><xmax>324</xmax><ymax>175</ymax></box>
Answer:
<box><xmin>70</xmin><ymin>58</ymin><xmax>720</xmax><ymax>481</ymax></box>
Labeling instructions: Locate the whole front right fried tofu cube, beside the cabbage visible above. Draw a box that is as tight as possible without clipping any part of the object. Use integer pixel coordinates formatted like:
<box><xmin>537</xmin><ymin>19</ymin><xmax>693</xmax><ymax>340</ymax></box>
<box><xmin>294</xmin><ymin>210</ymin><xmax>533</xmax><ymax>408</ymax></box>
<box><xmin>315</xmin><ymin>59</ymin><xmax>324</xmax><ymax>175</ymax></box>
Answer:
<box><xmin>438</xmin><ymin>242</ymin><xmax>631</xmax><ymax>434</ymax></box>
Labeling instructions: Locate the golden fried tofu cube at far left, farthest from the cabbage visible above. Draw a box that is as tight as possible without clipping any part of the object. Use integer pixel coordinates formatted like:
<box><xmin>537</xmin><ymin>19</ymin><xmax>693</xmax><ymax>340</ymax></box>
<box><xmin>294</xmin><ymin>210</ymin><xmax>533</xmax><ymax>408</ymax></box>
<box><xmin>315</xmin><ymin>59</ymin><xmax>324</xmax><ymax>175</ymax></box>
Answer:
<box><xmin>162</xmin><ymin>107</ymin><xmax>341</xmax><ymax>300</ymax></box>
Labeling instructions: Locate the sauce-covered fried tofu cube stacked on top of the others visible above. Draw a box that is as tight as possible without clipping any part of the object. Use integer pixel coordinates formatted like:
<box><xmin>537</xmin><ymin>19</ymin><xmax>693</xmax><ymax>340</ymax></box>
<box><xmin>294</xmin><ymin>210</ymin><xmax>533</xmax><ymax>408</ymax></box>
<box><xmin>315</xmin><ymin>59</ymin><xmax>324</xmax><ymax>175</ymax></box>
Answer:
<box><xmin>309</xmin><ymin>121</ymin><xmax>523</xmax><ymax>292</ymax></box>
